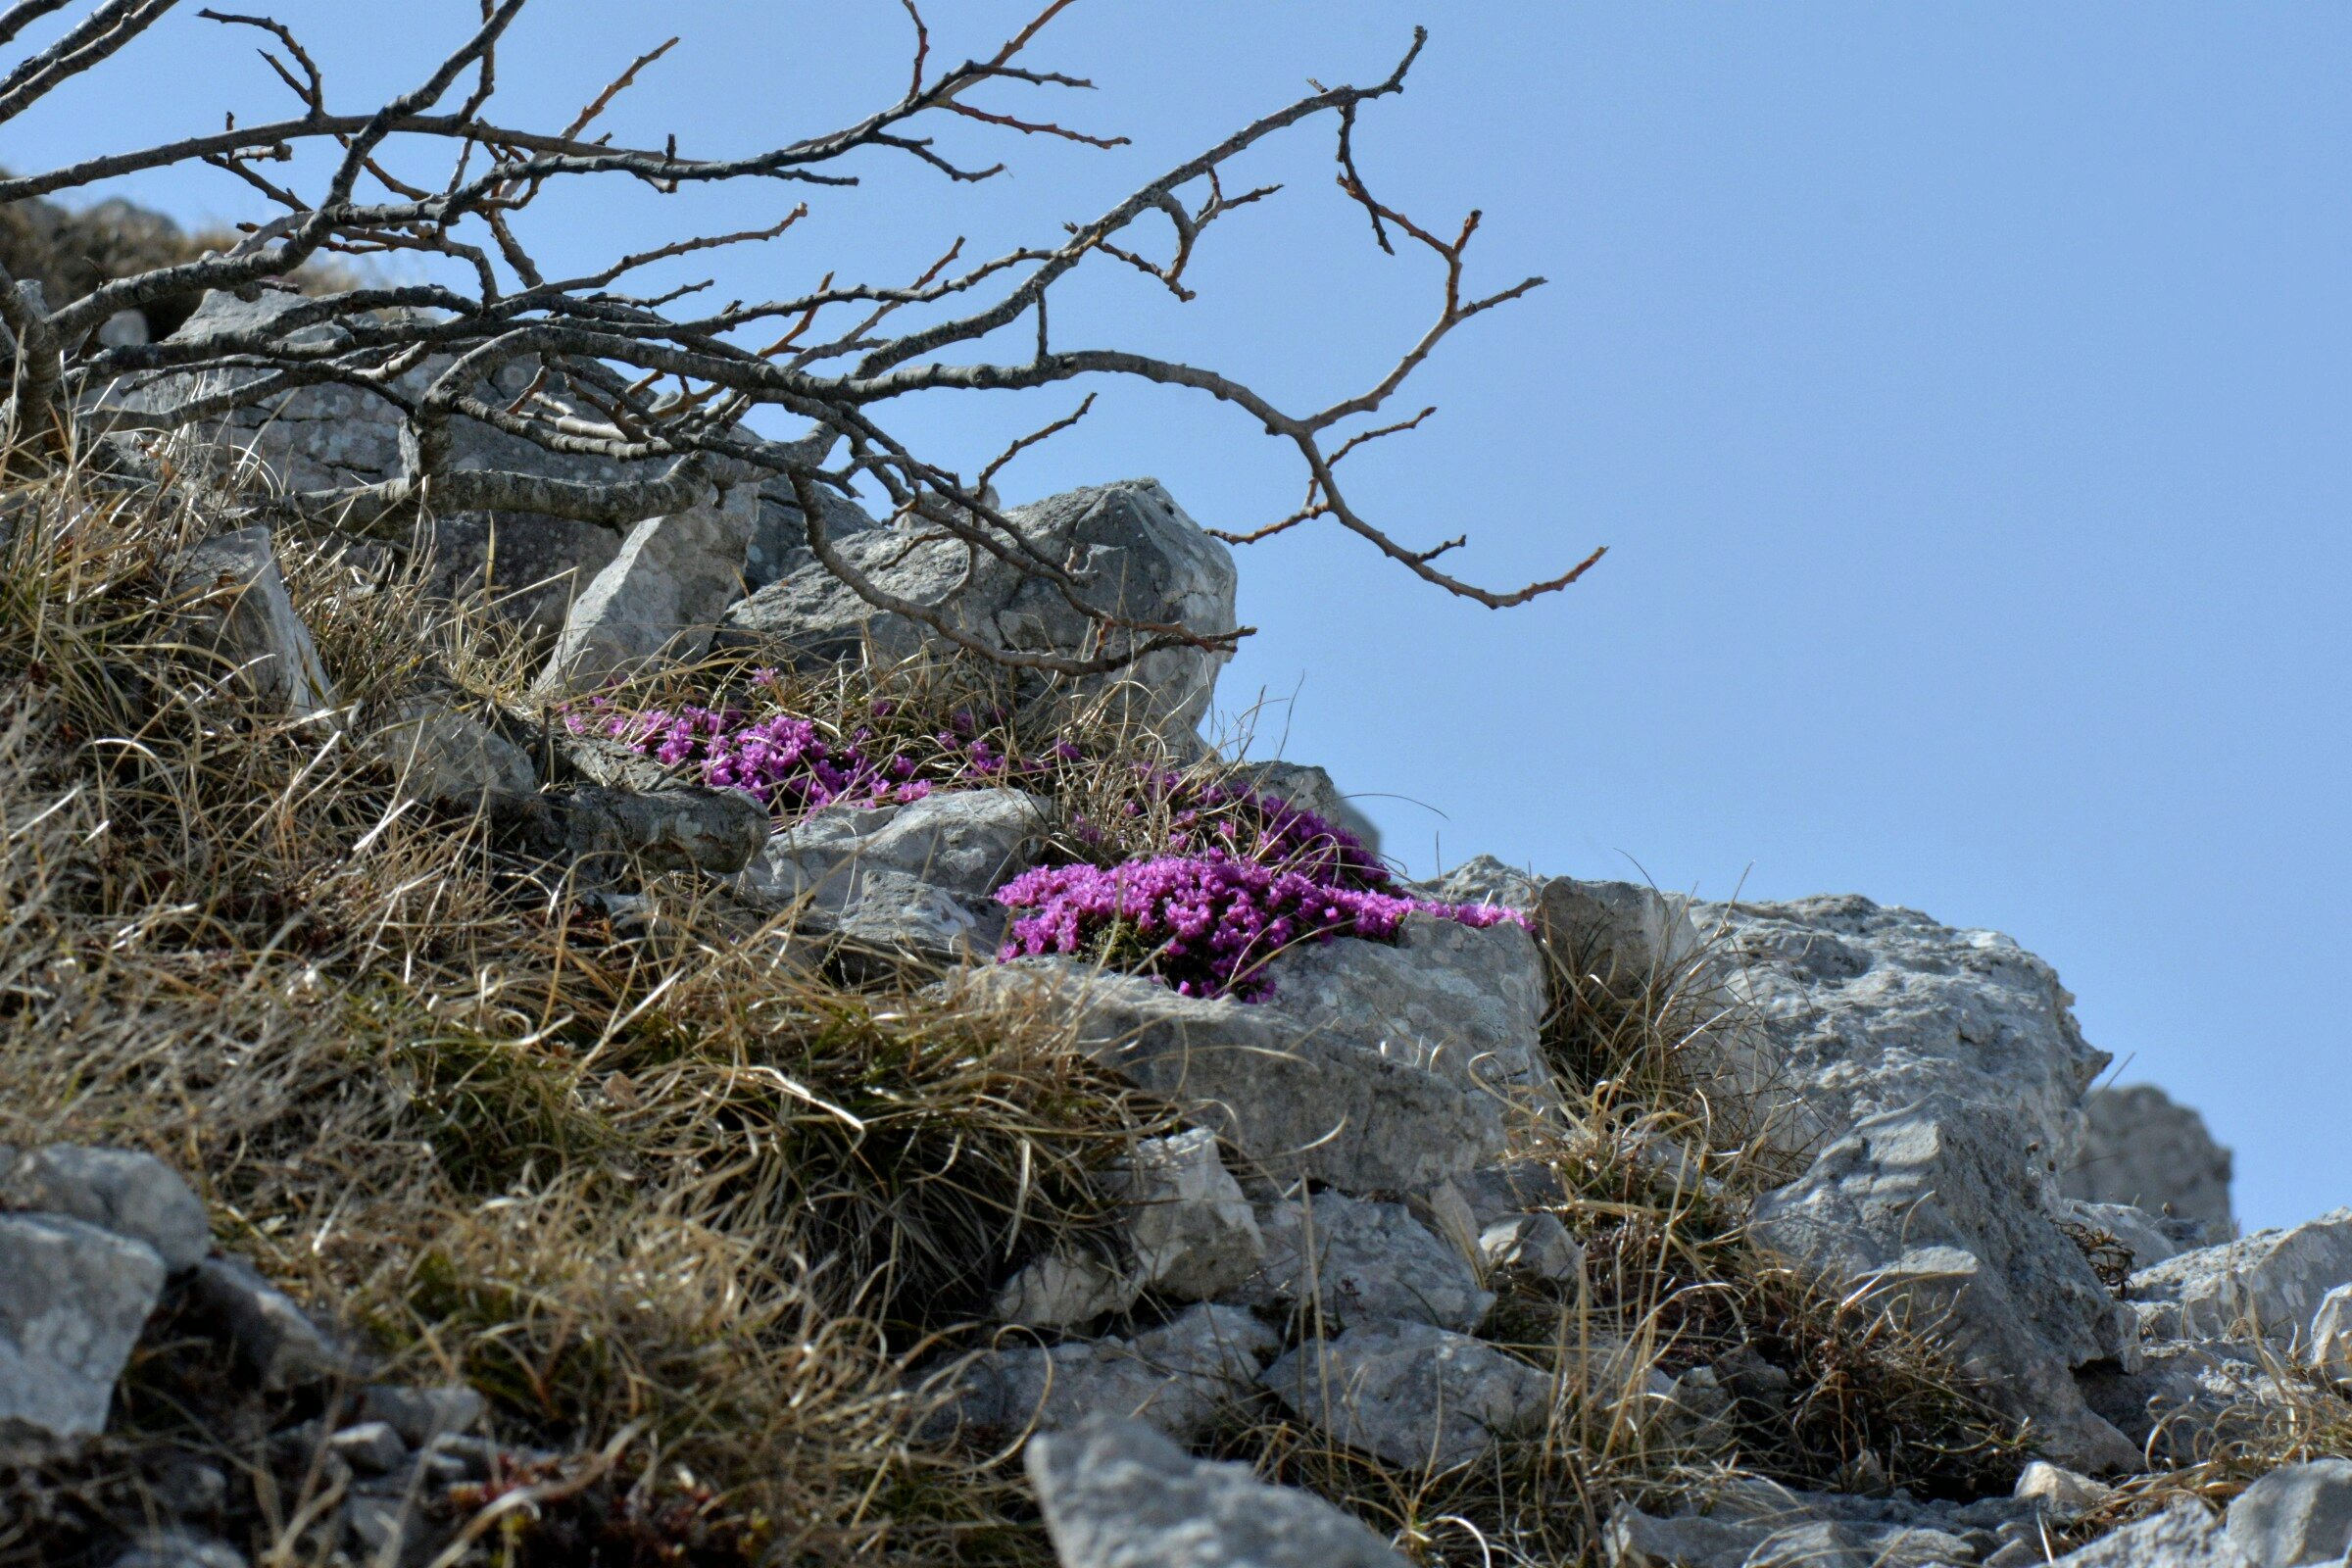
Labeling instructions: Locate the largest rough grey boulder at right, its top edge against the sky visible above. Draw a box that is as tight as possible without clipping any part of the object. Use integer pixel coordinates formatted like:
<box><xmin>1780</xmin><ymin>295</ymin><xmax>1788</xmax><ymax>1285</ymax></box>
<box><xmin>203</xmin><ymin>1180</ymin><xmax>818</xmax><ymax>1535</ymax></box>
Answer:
<box><xmin>1698</xmin><ymin>898</ymin><xmax>2138</xmax><ymax>1469</ymax></box>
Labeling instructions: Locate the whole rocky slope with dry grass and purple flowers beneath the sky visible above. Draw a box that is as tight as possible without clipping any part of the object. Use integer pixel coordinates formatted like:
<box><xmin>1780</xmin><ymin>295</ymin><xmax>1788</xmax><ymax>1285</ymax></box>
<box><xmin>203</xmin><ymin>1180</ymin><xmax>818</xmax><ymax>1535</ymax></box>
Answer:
<box><xmin>0</xmin><ymin>285</ymin><xmax>2352</xmax><ymax>1568</ymax></box>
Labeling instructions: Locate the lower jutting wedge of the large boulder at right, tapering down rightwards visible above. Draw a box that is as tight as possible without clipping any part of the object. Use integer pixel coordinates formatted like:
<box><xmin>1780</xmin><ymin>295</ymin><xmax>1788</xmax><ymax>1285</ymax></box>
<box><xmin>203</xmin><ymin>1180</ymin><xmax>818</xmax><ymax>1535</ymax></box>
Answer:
<box><xmin>1747</xmin><ymin>1096</ymin><xmax>2138</xmax><ymax>1469</ymax></box>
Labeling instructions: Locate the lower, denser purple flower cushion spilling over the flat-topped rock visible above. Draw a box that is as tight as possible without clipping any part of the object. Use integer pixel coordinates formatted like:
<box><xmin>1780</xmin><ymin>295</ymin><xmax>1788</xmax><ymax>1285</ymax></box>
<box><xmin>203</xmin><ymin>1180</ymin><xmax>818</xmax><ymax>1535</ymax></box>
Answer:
<box><xmin>998</xmin><ymin>849</ymin><xmax>1527</xmax><ymax>1002</ymax></box>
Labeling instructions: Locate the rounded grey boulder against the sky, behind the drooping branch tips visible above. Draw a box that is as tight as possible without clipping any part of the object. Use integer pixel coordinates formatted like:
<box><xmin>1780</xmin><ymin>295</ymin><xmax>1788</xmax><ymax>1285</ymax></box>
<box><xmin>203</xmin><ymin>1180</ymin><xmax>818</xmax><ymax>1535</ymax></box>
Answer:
<box><xmin>722</xmin><ymin>479</ymin><xmax>1235</xmax><ymax>731</ymax></box>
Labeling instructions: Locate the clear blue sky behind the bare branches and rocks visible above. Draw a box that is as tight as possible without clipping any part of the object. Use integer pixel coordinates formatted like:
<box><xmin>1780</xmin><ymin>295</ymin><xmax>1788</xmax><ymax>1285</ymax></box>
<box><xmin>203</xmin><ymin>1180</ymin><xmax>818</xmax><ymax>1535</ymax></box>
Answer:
<box><xmin>0</xmin><ymin>0</ymin><xmax>2352</xmax><ymax>1225</ymax></box>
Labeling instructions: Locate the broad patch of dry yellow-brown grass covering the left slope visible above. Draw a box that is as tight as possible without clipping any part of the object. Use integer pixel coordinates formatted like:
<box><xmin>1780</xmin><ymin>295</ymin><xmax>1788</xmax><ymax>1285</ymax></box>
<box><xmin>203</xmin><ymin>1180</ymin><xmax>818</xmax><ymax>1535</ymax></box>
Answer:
<box><xmin>0</xmin><ymin>446</ymin><xmax>1185</xmax><ymax>1563</ymax></box>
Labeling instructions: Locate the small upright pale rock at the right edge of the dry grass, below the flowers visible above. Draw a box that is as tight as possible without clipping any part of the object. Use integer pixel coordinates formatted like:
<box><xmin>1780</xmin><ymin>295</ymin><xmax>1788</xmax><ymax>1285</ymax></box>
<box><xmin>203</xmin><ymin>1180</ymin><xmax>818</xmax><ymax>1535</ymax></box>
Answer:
<box><xmin>1110</xmin><ymin>1128</ymin><xmax>1265</xmax><ymax>1300</ymax></box>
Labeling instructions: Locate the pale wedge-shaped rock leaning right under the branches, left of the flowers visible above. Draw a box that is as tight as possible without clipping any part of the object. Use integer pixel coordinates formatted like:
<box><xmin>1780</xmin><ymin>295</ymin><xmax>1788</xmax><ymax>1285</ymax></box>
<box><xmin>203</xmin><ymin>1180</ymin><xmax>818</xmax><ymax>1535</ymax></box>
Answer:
<box><xmin>536</xmin><ymin>484</ymin><xmax>760</xmax><ymax>696</ymax></box>
